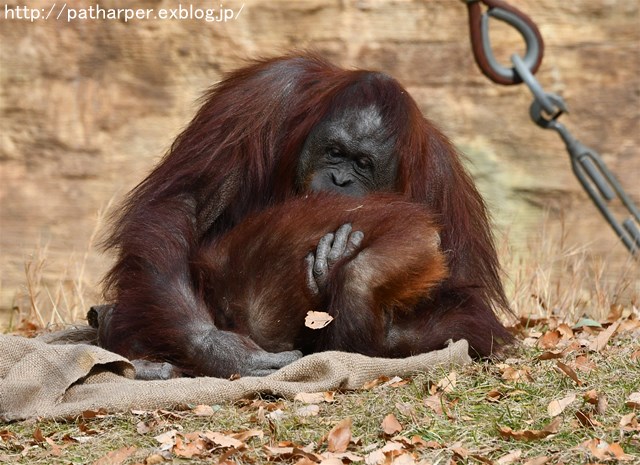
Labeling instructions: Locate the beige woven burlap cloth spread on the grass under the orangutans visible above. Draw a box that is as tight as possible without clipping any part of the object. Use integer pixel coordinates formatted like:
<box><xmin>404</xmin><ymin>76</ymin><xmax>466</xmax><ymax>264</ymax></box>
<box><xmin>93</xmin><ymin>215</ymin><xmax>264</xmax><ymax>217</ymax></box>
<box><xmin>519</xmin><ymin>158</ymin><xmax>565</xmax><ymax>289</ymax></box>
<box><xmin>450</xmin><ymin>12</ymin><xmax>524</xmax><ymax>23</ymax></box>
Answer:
<box><xmin>0</xmin><ymin>335</ymin><xmax>470</xmax><ymax>421</ymax></box>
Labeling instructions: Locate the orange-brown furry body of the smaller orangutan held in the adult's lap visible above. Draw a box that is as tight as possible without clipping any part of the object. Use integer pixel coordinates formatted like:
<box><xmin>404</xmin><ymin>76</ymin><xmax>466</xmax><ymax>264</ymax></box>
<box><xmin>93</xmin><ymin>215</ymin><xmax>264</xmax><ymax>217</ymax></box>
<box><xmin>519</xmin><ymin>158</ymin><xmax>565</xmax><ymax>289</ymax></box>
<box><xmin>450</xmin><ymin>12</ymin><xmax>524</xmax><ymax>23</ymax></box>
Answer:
<box><xmin>198</xmin><ymin>193</ymin><xmax>447</xmax><ymax>357</ymax></box>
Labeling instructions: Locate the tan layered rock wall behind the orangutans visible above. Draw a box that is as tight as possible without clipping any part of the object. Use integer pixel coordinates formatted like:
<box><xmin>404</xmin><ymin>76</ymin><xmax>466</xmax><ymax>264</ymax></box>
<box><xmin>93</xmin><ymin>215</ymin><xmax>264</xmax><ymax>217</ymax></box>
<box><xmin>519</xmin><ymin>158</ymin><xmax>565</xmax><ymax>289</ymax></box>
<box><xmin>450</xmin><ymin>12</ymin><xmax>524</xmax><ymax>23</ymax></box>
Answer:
<box><xmin>0</xmin><ymin>0</ymin><xmax>640</xmax><ymax>325</ymax></box>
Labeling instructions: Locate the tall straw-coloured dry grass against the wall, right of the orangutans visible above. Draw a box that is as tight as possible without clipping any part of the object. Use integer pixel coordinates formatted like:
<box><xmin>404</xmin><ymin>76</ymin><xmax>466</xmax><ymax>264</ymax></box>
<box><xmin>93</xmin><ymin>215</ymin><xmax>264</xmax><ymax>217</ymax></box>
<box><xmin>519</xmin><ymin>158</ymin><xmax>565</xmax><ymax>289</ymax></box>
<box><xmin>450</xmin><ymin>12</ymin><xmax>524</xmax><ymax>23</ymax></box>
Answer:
<box><xmin>500</xmin><ymin>213</ymin><xmax>640</xmax><ymax>322</ymax></box>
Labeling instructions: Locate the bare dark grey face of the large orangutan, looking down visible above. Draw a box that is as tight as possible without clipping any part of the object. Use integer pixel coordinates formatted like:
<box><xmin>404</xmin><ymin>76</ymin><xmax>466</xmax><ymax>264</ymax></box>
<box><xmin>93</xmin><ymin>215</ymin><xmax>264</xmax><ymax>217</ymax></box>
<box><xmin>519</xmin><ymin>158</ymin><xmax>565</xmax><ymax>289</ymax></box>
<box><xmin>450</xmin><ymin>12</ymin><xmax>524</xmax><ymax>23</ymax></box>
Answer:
<box><xmin>297</xmin><ymin>106</ymin><xmax>397</xmax><ymax>197</ymax></box>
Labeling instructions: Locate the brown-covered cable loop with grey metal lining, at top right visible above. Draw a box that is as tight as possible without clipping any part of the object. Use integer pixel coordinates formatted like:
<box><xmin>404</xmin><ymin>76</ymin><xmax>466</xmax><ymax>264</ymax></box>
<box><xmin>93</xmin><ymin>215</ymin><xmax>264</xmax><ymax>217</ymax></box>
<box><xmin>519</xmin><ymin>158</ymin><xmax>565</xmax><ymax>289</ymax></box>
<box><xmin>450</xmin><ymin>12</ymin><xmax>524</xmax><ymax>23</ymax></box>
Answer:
<box><xmin>462</xmin><ymin>0</ymin><xmax>544</xmax><ymax>85</ymax></box>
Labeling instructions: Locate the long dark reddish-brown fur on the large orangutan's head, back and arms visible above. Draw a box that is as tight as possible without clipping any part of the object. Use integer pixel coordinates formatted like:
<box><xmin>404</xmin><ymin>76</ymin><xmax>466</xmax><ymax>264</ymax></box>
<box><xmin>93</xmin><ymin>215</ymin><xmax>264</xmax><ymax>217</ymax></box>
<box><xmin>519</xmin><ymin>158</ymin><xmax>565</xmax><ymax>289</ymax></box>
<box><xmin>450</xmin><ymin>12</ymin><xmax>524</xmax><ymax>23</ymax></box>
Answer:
<box><xmin>101</xmin><ymin>54</ymin><xmax>511</xmax><ymax>371</ymax></box>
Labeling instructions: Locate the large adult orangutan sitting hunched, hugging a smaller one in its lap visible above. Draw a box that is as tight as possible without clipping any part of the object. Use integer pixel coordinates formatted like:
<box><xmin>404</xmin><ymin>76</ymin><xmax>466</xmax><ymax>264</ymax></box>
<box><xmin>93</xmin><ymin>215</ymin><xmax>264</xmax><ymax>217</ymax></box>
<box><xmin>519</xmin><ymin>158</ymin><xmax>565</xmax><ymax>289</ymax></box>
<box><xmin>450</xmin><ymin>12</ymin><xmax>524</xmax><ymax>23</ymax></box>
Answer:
<box><xmin>99</xmin><ymin>54</ymin><xmax>511</xmax><ymax>377</ymax></box>
